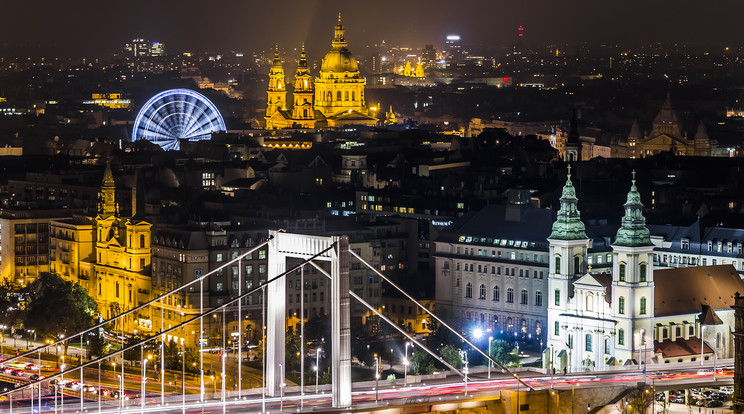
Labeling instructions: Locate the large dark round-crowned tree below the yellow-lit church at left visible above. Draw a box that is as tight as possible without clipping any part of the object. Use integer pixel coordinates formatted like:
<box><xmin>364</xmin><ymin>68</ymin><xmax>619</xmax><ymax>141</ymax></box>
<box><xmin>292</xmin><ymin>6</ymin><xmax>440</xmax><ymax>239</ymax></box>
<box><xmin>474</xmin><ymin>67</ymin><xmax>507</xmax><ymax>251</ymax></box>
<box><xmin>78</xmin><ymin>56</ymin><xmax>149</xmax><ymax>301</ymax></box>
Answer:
<box><xmin>25</xmin><ymin>273</ymin><xmax>97</xmax><ymax>355</ymax></box>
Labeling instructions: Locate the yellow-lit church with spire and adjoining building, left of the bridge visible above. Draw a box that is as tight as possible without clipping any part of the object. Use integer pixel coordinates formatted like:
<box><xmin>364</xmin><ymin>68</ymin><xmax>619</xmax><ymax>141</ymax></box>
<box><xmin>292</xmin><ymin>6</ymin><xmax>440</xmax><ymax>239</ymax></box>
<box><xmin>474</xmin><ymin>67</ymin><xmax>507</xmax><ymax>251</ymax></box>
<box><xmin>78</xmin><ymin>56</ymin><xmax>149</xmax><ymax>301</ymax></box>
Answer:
<box><xmin>50</xmin><ymin>164</ymin><xmax>152</xmax><ymax>333</ymax></box>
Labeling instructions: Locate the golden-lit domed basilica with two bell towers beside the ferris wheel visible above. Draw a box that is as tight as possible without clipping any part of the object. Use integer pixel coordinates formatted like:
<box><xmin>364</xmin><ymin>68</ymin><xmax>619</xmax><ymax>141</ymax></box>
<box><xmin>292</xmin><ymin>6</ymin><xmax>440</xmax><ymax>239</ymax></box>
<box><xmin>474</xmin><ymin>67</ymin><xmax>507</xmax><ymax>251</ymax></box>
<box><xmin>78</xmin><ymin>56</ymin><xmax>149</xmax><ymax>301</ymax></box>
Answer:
<box><xmin>265</xmin><ymin>15</ymin><xmax>378</xmax><ymax>129</ymax></box>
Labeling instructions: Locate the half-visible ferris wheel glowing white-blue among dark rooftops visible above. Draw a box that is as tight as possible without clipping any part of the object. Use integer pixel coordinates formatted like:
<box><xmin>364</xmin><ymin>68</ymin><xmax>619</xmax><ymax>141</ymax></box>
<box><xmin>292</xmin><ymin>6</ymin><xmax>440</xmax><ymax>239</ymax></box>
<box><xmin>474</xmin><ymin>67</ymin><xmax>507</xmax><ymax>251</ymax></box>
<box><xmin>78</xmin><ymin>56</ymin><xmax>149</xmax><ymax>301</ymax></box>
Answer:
<box><xmin>132</xmin><ymin>89</ymin><xmax>227</xmax><ymax>151</ymax></box>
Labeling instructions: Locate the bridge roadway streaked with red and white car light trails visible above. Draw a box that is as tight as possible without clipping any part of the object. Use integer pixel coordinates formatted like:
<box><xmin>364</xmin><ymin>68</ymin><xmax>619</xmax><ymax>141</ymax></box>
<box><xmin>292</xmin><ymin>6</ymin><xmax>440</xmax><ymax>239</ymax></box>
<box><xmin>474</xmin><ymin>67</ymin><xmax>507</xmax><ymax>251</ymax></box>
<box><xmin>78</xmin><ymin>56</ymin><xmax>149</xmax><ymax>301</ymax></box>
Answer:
<box><xmin>2</xmin><ymin>364</ymin><xmax>733</xmax><ymax>413</ymax></box>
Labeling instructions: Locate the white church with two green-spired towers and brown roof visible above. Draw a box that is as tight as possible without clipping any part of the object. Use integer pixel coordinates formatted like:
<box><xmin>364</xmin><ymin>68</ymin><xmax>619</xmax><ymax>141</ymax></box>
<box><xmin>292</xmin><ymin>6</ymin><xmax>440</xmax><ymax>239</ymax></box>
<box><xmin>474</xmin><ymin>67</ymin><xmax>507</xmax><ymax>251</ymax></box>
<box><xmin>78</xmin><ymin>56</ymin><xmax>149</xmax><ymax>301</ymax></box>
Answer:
<box><xmin>543</xmin><ymin>167</ymin><xmax>744</xmax><ymax>372</ymax></box>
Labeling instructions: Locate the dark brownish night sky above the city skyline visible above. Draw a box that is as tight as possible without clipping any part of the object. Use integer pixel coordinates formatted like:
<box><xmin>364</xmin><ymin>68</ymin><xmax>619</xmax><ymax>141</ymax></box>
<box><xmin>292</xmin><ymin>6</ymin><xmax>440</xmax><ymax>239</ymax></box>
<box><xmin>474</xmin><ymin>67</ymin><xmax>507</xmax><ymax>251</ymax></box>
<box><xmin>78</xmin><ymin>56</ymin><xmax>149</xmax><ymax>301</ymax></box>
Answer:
<box><xmin>0</xmin><ymin>0</ymin><xmax>744</xmax><ymax>57</ymax></box>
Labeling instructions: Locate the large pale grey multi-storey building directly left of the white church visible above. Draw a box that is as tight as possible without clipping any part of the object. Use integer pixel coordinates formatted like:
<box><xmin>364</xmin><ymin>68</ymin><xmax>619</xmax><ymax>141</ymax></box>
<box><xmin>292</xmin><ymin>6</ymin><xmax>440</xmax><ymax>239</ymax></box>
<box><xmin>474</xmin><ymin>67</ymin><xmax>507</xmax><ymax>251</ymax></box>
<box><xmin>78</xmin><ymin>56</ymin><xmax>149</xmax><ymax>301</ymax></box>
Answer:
<box><xmin>434</xmin><ymin>205</ymin><xmax>552</xmax><ymax>340</ymax></box>
